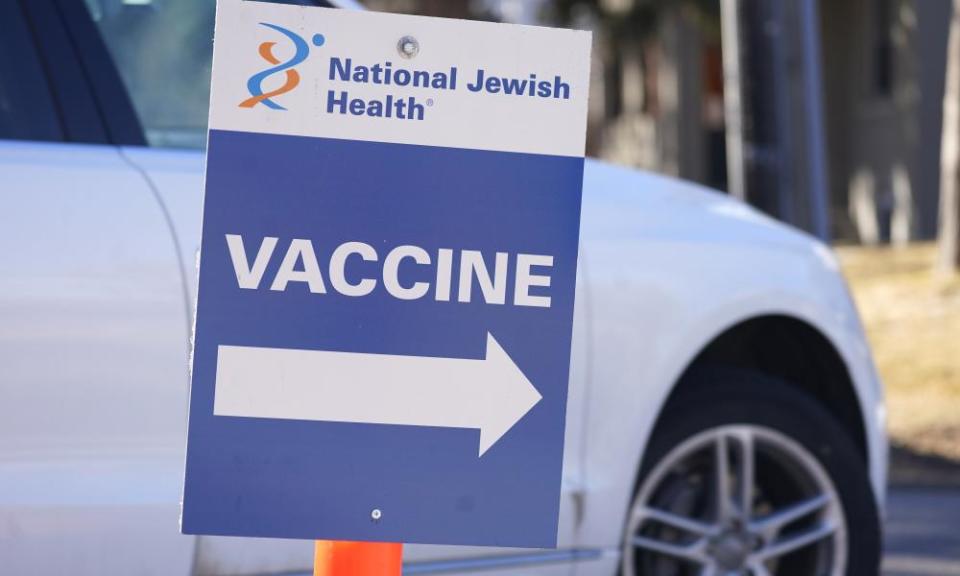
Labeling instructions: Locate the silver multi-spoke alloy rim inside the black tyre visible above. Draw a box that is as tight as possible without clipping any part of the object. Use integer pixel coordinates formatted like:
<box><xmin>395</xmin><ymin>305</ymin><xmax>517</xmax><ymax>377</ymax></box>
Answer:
<box><xmin>622</xmin><ymin>424</ymin><xmax>847</xmax><ymax>576</ymax></box>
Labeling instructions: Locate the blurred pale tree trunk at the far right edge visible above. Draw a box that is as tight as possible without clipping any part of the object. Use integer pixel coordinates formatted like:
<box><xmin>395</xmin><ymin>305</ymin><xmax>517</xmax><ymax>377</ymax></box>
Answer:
<box><xmin>940</xmin><ymin>0</ymin><xmax>960</xmax><ymax>272</ymax></box>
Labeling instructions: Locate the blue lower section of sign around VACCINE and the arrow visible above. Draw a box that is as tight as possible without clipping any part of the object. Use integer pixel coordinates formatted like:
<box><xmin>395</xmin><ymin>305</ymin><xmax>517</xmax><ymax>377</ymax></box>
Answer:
<box><xmin>183</xmin><ymin>131</ymin><xmax>583</xmax><ymax>547</ymax></box>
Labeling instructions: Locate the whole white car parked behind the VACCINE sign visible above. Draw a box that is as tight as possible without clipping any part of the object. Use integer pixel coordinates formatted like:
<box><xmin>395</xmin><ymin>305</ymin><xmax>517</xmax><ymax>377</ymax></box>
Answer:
<box><xmin>0</xmin><ymin>0</ymin><xmax>887</xmax><ymax>576</ymax></box>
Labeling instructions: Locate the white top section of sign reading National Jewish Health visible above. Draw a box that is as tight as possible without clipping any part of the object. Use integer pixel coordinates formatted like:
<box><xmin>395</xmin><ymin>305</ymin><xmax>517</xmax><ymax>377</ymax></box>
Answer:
<box><xmin>210</xmin><ymin>0</ymin><xmax>591</xmax><ymax>156</ymax></box>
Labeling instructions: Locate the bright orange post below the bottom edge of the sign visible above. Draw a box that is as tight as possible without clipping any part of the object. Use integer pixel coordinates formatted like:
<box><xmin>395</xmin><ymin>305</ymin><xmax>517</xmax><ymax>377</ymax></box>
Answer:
<box><xmin>313</xmin><ymin>540</ymin><xmax>403</xmax><ymax>576</ymax></box>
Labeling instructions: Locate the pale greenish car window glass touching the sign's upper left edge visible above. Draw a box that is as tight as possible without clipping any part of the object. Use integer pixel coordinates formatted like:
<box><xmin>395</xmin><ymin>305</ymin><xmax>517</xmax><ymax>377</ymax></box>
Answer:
<box><xmin>85</xmin><ymin>0</ymin><xmax>216</xmax><ymax>148</ymax></box>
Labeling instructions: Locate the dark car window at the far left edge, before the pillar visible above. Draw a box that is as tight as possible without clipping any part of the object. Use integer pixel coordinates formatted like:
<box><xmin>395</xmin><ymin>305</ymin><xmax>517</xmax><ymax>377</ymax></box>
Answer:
<box><xmin>0</xmin><ymin>2</ymin><xmax>63</xmax><ymax>141</ymax></box>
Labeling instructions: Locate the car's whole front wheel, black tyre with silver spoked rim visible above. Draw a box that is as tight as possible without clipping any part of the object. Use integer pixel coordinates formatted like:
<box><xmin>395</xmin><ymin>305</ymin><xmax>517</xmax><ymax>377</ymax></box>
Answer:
<box><xmin>621</xmin><ymin>370</ymin><xmax>880</xmax><ymax>576</ymax></box>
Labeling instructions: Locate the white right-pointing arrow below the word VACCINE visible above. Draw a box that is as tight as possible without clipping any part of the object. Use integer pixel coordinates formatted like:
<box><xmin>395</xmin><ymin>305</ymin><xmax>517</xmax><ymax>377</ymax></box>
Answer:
<box><xmin>213</xmin><ymin>333</ymin><xmax>542</xmax><ymax>456</ymax></box>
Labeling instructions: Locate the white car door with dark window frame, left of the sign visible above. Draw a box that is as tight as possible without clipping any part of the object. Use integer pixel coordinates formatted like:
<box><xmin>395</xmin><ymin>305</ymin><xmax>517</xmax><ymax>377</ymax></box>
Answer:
<box><xmin>0</xmin><ymin>0</ymin><xmax>193</xmax><ymax>575</ymax></box>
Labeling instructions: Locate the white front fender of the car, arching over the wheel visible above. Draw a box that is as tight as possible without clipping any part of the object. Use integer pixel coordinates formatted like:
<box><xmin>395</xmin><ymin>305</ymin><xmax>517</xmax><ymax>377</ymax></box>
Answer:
<box><xmin>579</xmin><ymin>163</ymin><xmax>887</xmax><ymax>547</ymax></box>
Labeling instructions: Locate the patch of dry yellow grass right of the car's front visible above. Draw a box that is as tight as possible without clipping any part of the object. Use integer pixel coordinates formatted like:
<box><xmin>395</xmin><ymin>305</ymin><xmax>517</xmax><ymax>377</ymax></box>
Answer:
<box><xmin>837</xmin><ymin>244</ymin><xmax>960</xmax><ymax>461</ymax></box>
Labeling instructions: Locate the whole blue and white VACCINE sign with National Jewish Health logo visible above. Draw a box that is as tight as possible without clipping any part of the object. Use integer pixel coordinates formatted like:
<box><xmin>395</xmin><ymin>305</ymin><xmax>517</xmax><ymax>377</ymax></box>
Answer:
<box><xmin>182</xmin><ymin>1</ymin><xmax>590</xmax><ymax>547</ymax></box>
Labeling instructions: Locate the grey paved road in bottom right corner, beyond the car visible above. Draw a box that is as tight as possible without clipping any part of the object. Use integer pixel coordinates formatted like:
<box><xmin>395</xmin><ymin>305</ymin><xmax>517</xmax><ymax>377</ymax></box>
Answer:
<box><xmin>883</xmin><ymin>488</ymin><xmax>960</xmax><ymax>576</ymax></box>
